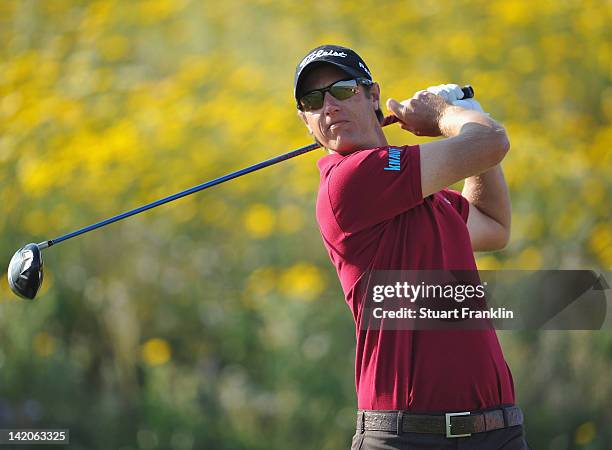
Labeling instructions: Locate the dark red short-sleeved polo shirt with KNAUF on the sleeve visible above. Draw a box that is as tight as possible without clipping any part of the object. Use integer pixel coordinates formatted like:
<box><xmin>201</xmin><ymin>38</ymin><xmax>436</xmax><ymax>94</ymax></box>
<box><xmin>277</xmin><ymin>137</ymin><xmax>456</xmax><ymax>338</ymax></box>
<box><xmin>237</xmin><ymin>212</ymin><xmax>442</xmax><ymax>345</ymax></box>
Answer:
<box><xmin>317</xmin><ymin>146</ymin><xmax>515</xmax><ymax>412</ymax></box>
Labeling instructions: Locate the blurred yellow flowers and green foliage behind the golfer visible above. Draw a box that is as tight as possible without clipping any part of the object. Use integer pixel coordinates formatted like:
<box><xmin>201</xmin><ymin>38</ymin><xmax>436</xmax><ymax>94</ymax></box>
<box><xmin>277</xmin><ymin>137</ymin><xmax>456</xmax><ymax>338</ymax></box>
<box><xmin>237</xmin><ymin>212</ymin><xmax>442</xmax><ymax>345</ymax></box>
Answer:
<box><xmin>0</xmin><ymin>0</ymin><xmax>612</xmax><ymax>450</ymax></box>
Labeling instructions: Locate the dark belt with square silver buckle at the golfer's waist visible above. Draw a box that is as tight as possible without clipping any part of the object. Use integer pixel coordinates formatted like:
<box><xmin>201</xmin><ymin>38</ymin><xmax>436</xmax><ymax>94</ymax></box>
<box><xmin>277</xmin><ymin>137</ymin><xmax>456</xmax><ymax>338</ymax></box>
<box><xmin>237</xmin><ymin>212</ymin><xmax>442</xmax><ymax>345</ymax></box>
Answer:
<box><xmin>357</xmin><ymin>406</ymin><xmax>523</xmax><ymax>438</ymax></box>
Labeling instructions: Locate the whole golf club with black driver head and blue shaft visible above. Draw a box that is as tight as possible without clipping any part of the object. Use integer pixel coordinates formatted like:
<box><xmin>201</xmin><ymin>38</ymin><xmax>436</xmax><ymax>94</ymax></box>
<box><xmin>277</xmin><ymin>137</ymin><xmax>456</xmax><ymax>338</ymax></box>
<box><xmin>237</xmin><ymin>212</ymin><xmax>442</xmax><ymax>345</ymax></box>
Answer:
<box><xmin>7</xmin><ymin>85</ymin><xmax>474</xmax><ymax>299</ymax></box>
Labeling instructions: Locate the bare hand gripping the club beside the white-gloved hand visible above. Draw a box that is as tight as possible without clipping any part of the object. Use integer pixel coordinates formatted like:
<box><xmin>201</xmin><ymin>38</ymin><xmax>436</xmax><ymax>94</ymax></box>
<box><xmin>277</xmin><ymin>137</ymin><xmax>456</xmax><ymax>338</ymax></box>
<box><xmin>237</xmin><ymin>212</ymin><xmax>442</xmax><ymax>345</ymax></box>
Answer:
<box><xmin>387</xmin><ymin>91</ymin><xmax>452</xmax><ymax>137</ymax></box>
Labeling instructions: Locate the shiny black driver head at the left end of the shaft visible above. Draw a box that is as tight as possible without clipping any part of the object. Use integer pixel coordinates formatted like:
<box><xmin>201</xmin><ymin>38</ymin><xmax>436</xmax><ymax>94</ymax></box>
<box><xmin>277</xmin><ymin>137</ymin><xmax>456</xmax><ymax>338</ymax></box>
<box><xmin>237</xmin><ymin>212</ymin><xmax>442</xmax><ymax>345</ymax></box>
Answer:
<box><xmin>8</xmin><ymin>244</ymin><xmax>43</xmax><ymax>300</ymax></box>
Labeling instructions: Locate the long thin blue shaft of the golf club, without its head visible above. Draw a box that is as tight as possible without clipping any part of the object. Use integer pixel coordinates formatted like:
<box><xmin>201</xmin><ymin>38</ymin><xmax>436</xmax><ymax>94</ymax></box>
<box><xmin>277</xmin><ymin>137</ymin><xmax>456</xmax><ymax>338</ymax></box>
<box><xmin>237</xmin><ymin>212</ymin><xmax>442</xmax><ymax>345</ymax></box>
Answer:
<box><xmin>37</xmin><ymin>85</ymin><xmax>474</xmax><ymax>250</ymax></box>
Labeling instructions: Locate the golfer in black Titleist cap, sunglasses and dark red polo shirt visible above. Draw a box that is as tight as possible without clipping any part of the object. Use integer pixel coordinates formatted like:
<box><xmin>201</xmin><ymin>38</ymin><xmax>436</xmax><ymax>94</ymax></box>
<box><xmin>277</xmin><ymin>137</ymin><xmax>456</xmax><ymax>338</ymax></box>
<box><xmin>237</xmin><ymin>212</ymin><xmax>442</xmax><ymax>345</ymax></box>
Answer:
<box><xmin>294</xmin><ymin>45</ymin><xmax>528</xmax><ymax>450</ymax></box>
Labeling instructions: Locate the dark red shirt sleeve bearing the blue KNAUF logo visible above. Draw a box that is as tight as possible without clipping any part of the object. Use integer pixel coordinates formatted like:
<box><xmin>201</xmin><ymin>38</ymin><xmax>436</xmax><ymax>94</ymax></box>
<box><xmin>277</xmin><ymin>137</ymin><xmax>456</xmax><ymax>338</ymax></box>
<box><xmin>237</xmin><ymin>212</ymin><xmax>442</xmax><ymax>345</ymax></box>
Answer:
<box><xmin>328</xmin><ymin>145</ymin><xmax>423</xmax><ymax>233</ymax></box>
